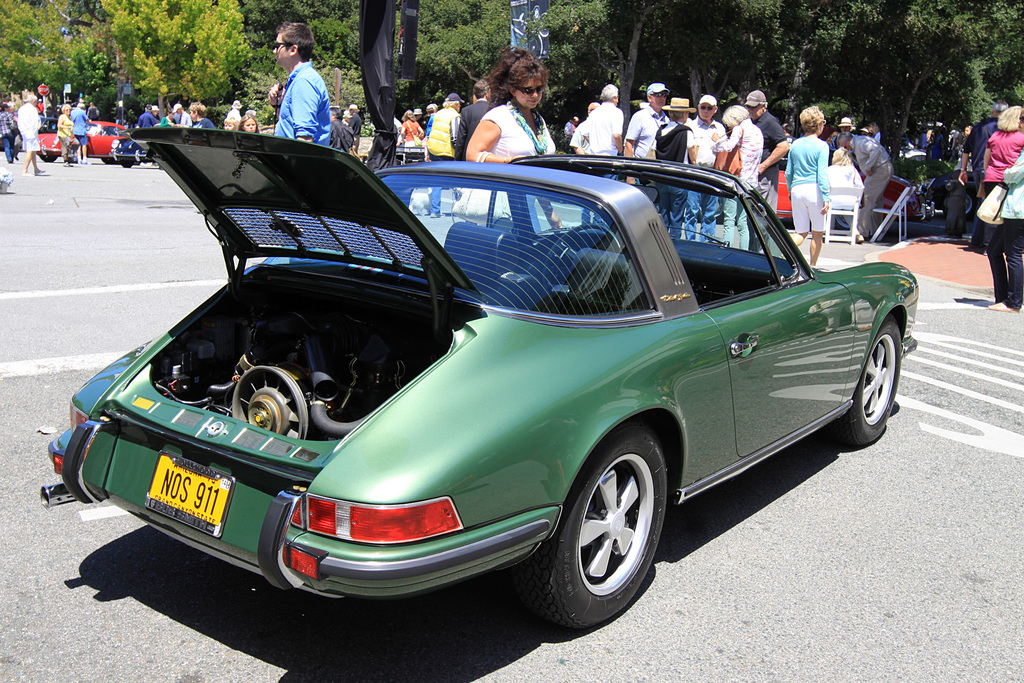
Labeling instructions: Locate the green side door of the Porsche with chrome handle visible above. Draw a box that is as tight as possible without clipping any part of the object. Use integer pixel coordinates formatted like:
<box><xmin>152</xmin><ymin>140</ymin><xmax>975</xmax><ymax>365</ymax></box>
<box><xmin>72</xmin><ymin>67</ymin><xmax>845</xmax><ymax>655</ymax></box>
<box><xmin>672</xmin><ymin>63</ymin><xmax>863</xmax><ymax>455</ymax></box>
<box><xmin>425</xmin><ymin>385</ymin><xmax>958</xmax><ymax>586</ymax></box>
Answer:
<box><xmin>706</xmin><ymin>197</ymin><xmax>858</xmax><ymax>458</ymax></box>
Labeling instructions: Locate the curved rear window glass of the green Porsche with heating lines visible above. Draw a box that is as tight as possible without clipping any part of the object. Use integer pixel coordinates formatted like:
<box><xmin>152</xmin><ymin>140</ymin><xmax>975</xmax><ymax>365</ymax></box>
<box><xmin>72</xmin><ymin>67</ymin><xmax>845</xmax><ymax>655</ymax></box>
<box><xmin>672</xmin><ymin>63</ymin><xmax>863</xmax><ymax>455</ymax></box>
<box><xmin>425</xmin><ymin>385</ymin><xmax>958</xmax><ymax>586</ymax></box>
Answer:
<box><xmin>383</xmin><ymin>174</ymin><xmax>650</xmax><ymax>315</ymax></box>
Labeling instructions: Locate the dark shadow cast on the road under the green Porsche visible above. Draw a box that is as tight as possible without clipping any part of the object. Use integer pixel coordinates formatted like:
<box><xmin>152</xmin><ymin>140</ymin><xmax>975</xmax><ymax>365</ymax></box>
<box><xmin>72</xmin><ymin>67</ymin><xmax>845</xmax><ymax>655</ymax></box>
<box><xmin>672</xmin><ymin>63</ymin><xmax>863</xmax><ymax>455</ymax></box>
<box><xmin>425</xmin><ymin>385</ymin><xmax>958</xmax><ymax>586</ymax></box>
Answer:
<box><xmin>66</xmin><ymin>437</ymin><xmax>841</xmax><ymax>681</ymax></box>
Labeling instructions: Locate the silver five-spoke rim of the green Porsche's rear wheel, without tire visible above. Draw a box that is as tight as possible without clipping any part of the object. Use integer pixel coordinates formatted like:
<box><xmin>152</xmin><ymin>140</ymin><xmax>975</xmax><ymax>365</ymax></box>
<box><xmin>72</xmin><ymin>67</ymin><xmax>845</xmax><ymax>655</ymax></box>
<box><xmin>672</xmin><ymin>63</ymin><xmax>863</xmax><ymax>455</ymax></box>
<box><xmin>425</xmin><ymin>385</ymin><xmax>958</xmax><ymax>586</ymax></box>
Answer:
<box><xmin>578</xmin><ymin>453</ymin><xmax>654</xmax><ymax>595</ymax></box>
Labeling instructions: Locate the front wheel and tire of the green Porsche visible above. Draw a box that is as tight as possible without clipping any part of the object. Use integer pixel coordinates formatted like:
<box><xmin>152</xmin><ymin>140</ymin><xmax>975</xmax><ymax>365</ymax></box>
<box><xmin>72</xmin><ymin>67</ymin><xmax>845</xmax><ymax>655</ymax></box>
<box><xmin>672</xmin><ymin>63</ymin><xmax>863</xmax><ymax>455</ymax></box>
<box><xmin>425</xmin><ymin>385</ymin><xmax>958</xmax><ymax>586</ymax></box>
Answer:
<box><xmin>829</xmin><ymin>317</ymin><xmax>903</xmax><ymax>446</ymax></box>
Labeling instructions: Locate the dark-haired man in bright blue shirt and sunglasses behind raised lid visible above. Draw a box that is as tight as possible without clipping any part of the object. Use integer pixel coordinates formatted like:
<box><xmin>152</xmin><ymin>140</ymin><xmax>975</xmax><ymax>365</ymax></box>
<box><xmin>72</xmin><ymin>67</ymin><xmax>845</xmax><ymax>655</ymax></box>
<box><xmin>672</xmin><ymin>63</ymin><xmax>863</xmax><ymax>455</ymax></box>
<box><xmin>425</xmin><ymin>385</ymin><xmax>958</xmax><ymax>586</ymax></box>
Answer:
<box><xmin>267</xmin><ymin>22</ymin><xmax>331</xmax><ymax>145</ymax></box>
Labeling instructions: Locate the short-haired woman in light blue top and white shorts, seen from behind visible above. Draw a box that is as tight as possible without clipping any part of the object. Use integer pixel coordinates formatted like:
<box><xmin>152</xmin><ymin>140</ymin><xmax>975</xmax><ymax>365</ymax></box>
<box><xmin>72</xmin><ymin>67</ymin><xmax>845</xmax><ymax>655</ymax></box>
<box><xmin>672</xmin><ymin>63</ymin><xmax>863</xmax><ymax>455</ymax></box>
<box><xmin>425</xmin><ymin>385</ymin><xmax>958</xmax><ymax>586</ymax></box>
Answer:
<box><xmin>785</xmin><ymin>106</ymin><xmax>829</xmax><ymax>265</ymax></box>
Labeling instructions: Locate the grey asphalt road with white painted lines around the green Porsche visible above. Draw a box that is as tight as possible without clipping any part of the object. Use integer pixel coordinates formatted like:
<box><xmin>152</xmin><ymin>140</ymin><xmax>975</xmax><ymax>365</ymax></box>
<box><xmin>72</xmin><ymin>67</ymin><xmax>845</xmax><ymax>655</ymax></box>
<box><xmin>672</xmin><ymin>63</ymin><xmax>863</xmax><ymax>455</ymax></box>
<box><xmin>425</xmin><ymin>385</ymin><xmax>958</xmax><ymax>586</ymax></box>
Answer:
<box><xmin>0</xmin><ymin>166</ymin><xmax>1024</xmax><ymax>683</ymax></box>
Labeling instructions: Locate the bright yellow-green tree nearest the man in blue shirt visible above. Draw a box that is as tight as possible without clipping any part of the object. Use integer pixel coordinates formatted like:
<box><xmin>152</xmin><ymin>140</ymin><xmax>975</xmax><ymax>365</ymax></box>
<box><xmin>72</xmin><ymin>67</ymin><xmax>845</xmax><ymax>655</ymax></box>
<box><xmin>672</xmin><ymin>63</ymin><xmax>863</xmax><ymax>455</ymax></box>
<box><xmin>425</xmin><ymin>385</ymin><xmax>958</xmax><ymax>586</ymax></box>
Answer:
<box><xmin>103</xmin><ymin>0</ymin><xmax>249</xmax><ymax>105</ymax></box>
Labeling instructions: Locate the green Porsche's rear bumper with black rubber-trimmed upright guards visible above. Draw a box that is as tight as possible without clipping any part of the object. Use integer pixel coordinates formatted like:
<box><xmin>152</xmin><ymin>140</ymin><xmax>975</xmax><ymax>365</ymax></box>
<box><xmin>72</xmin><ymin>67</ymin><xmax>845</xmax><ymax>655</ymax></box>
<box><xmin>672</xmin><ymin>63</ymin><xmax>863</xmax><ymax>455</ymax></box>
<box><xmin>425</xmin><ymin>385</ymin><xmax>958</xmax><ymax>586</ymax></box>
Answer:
<box><xmin>49</xmin><ymin>421</ymin><xmax>559</xmax><ymax>598</ymax></box>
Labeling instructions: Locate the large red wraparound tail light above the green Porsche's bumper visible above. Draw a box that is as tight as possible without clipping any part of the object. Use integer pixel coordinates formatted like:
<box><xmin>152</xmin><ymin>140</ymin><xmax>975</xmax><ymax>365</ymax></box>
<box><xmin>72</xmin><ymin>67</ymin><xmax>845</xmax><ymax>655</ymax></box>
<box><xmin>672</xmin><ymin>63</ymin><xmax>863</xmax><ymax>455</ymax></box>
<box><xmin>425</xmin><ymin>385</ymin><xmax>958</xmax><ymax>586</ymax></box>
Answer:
<box><xmin>292</xmin><ymin>495</ymin><xmax>462</xmax><ymax>544</ymax></box>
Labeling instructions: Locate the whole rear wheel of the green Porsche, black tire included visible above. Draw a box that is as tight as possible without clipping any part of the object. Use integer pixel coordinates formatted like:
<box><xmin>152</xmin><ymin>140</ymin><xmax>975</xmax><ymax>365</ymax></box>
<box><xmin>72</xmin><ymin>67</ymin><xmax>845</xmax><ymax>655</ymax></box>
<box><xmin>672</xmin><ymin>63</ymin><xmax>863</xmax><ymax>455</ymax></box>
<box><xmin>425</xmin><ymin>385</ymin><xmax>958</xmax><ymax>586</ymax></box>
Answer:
<box><xmin>513</xmin><ymin>425</ymin><xmax>667</xmax><ymax>629</ymax></box>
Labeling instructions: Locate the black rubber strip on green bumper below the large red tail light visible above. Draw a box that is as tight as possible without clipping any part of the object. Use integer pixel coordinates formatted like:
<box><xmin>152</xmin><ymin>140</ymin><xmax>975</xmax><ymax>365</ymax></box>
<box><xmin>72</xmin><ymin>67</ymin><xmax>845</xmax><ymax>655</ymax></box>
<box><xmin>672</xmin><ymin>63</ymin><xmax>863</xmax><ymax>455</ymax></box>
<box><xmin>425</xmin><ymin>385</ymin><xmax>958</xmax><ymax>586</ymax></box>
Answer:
<box><xmin>321</xmin><ymin>519</ymin><xmax>551</xmax><ymax>581</ymax></box>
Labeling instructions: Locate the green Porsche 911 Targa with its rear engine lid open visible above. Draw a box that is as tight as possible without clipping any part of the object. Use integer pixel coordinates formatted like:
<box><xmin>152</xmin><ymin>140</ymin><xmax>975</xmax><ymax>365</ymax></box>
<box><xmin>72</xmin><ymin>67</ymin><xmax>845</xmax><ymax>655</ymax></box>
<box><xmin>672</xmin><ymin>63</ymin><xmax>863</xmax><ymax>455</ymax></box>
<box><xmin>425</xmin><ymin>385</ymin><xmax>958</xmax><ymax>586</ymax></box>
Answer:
<box><xmin>42</xmin><ymin>128</ymin><xmax>919</xmax><ymax>628</ymax></box>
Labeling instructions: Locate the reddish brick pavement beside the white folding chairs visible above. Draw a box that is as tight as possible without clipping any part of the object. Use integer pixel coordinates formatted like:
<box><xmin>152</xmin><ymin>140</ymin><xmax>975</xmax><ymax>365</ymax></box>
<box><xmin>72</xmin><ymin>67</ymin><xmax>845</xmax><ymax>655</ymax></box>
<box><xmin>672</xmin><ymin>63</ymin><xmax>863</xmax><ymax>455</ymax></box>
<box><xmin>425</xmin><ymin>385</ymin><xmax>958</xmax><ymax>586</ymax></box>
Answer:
<box><xmin>879</xmin><ymin>239</ymin><xmax>992</xmax><ymax>288</ymax></box>
